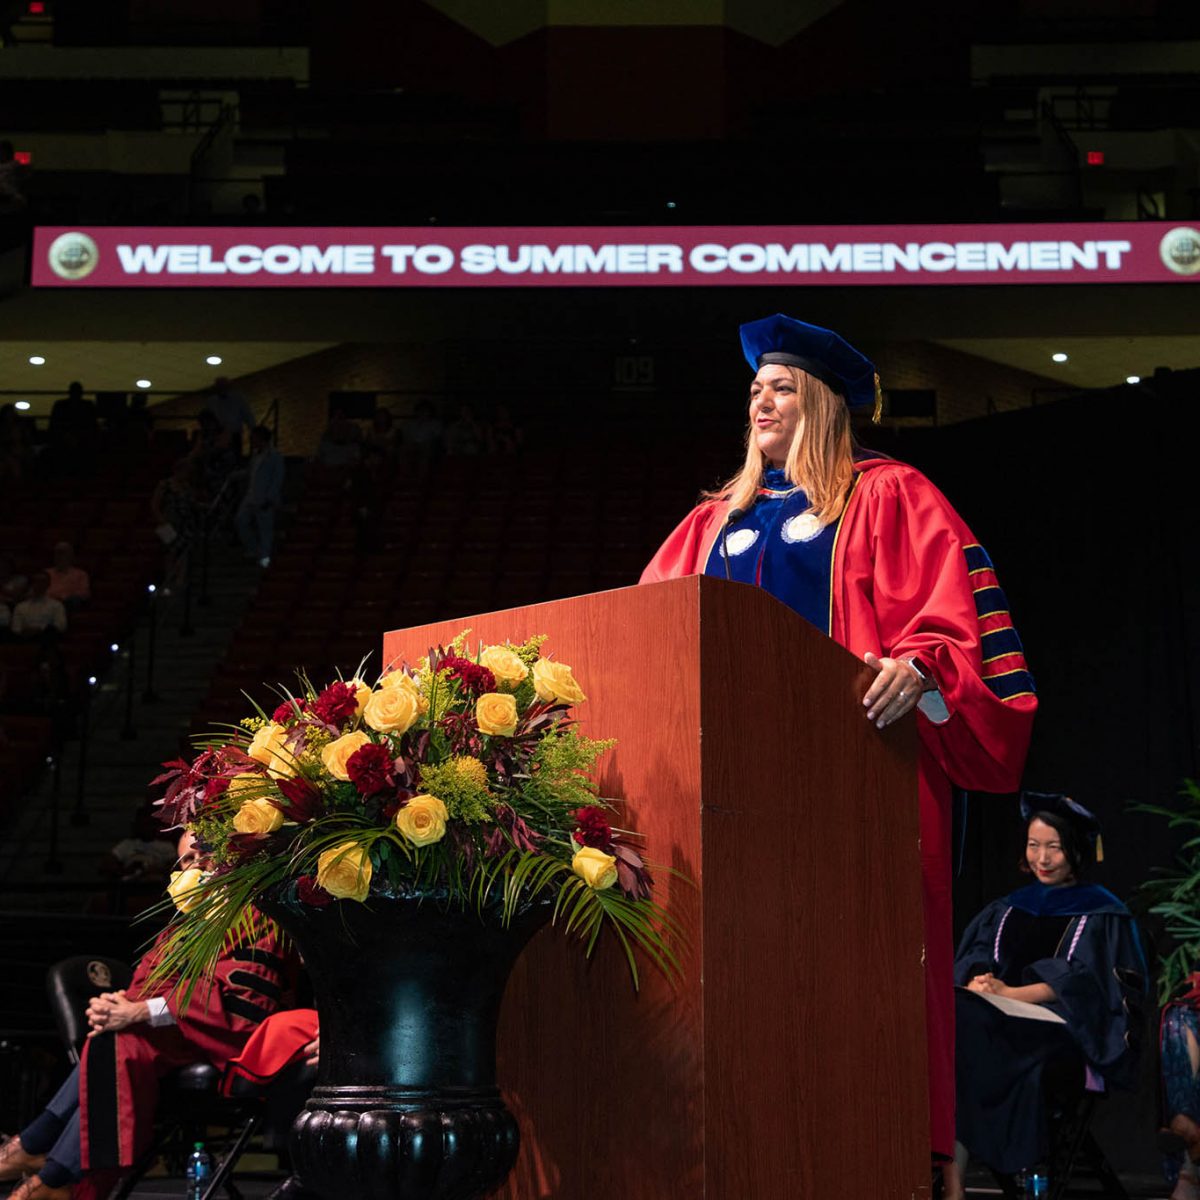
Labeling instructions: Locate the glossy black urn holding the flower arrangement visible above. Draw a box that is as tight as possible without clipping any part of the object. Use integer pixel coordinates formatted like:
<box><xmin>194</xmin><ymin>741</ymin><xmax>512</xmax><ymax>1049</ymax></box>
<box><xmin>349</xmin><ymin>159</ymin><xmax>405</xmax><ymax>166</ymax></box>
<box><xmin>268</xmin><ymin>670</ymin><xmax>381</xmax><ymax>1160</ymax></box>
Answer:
<box><xmin>262</xmin><ymin>892</ymin><xmax>551</xmax><ymax>1200</ymax></box>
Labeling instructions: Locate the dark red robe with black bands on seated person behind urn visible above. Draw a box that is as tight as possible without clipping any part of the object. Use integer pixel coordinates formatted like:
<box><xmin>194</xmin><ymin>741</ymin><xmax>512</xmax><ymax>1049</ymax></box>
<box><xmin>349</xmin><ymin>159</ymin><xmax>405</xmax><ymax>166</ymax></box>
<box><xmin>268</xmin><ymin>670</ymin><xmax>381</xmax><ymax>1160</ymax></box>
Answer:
<box><xmin>79</xmin><ymin>923</ymin><xmax>289</xmax><ymax>1170</ymax></box>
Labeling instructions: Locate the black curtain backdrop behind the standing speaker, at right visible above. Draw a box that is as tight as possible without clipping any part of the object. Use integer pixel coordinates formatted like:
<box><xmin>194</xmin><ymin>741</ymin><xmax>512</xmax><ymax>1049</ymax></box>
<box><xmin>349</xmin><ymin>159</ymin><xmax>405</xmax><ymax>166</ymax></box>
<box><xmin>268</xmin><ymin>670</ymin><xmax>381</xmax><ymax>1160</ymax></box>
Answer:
<box><xmin>876</xmin><ymin>371</ymin><xmax>1200</xmax><ymax>928</ymax></box>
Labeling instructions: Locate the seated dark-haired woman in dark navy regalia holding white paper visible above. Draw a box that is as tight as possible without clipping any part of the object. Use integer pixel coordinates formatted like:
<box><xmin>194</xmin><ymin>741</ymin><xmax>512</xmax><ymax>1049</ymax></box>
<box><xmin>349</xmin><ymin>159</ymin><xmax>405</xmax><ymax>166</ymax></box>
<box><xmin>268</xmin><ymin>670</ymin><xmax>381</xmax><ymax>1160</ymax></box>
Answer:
<box><xmin>954</xmin><ymin>792</ymin><xmax>1146</xmax><ymax>1190</ymax></box>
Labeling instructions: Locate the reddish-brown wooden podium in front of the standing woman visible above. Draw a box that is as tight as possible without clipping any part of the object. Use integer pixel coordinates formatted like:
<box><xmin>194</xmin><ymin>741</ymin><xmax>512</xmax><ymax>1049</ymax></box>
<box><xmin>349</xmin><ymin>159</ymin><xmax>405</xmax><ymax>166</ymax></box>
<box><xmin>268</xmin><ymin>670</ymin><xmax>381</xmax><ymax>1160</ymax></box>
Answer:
<box><xmin>384</xmin><ymin>576</ymin><xmax>930</xmax><ymax>1200</ymax></box>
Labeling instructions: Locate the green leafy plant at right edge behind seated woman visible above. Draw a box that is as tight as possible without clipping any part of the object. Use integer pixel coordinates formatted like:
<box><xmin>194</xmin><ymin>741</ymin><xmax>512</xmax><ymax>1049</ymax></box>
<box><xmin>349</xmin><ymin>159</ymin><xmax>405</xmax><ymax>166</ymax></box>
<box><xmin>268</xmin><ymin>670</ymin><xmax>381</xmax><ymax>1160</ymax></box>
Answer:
<box><xmin>1130</xmin><ymin>779</ymin><xmax>1200</xmax><ymax>1004</ymax></box>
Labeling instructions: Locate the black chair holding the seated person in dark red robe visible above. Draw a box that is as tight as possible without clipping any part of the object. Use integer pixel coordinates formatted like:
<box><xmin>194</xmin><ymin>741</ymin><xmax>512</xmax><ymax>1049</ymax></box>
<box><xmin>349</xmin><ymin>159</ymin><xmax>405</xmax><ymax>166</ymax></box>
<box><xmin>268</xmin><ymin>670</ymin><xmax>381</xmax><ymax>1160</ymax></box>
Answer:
<box><xmin>46</xmin><ymin>954</ymin><xmax>279</xmax><ymax>1200</ymax></box>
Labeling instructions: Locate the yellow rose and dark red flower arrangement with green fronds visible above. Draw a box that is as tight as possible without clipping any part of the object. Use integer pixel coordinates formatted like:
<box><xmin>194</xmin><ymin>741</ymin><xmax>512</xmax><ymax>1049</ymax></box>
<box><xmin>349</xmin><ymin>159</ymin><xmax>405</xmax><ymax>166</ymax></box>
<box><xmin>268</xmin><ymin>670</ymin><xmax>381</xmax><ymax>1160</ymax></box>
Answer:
<box><xmin>154</xmin><ymin>632</ymin><xmax>680</xmax><ymax>986</ymax></box>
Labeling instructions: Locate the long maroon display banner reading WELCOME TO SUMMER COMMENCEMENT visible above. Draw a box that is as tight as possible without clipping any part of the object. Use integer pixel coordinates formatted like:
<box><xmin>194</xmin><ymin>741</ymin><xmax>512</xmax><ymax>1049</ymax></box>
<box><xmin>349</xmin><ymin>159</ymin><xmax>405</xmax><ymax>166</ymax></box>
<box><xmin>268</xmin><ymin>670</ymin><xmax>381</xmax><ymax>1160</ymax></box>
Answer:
<box><xmin>31</xmin><ymin>221</ymin><xmax>1200</xmax><ymax>288</ymax></box>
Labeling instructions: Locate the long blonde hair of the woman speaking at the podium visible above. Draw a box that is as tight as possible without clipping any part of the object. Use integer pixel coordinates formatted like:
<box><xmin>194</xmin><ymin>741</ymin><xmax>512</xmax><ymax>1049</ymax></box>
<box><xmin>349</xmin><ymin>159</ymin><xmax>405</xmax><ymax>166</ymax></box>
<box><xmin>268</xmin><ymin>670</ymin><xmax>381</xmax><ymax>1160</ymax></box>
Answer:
<box><xmin>704</xmin><ymin>366</ymin><xmax>856</xmax><ymax>524</ymax></box>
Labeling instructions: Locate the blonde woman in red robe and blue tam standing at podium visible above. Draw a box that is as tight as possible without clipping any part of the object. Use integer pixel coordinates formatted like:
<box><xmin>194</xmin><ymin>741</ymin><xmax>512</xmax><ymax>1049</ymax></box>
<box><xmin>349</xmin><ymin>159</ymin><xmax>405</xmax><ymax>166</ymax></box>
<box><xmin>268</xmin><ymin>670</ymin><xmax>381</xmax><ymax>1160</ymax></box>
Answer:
<box><xmin>642</xmin><ymin>314</ymin><xmax>1037</xmax><ymax>1180</ymax></box>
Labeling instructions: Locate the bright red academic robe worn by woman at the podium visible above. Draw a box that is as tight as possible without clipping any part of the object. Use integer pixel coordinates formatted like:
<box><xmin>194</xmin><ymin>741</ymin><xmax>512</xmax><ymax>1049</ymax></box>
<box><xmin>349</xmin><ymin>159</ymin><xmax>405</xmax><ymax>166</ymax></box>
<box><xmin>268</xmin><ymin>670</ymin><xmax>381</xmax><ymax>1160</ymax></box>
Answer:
<box><xmin>641</xmin><ymin>458</ymin><xmax>1037</xmax><ymax>1154</ymax></box>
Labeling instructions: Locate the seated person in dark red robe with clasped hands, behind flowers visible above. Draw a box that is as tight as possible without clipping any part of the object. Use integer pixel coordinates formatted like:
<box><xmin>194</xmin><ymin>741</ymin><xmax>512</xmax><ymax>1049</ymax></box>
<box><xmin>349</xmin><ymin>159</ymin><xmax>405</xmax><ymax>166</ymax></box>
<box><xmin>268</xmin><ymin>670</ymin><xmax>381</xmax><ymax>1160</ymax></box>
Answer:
<box><xmin>0</xmin><ymin>833</ymin><xmax>292</xmax><ymax>1200</ymax></box>
